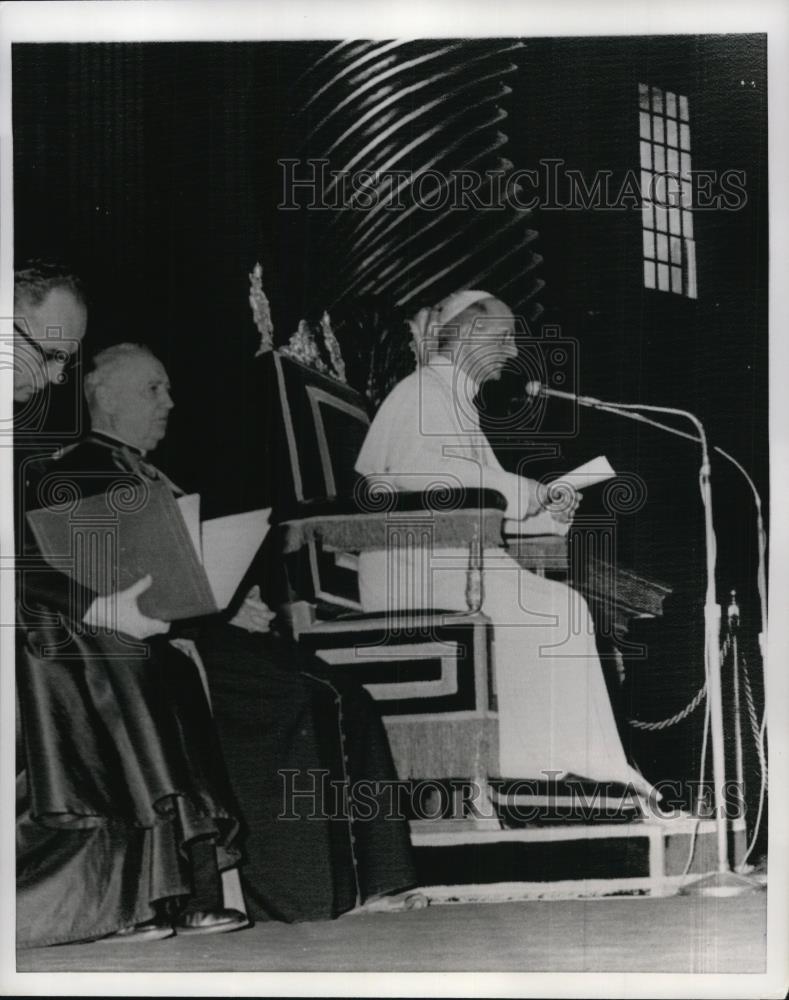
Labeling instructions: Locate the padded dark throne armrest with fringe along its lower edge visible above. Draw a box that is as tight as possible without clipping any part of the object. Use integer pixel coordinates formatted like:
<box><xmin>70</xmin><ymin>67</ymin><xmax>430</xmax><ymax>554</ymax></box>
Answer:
<box><xmin>281</xmin><ymin>489</ymin><xmax>507</xmax><ymax>554</ymax></box>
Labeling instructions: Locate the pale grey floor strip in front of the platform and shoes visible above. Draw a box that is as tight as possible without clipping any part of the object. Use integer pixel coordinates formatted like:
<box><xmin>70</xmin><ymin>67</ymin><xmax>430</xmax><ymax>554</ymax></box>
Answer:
<box><xmin>17</xmin><ymin>892</ymin><xmax>767</xmax><ymax>973</ymax></box>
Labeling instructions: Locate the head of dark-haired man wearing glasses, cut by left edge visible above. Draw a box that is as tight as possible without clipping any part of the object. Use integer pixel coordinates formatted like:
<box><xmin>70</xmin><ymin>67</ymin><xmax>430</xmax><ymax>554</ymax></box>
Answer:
<box><xmin>14</xmin><ymin>261</ymin><xmax>88</xmax><ymax>403</ymax></box>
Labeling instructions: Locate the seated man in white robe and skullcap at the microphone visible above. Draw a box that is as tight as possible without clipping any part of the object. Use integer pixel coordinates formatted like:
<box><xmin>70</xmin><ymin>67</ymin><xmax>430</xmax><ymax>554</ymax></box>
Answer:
<box><xmin>356</xmin><ymin>291</ymin><xmax>650</xmax><ymax>793</ymax></box>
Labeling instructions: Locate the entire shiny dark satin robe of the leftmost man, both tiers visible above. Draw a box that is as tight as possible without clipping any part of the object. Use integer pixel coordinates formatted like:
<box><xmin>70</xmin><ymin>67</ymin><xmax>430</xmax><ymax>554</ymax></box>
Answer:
<box><xmin>16</xmin><ymin>439</ymin><xmax>238</xmax><ymax>947</ymax></box>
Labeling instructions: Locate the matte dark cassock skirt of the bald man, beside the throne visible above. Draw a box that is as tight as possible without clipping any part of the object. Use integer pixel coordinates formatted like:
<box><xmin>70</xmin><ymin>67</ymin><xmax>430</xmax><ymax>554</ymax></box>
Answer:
<box><xmin>195</xmin><ymin>619</ymin><xmax>415</xmax><ymax>921</ymax></box>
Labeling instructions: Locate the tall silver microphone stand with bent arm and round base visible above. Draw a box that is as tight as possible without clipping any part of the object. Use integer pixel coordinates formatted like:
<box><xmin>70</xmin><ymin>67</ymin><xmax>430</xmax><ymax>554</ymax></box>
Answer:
<box><xmin>568</xmin><ymin>393</ymin><xmax>766</xmax><ymax>896</ymax></box>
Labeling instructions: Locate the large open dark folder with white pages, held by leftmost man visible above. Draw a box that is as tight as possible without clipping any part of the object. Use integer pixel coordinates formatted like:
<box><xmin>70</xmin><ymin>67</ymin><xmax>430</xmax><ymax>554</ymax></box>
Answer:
<box><xmin>27</xmin><ymin>482</ymin><xmax>271</xmax><ymax>621</ymax></box>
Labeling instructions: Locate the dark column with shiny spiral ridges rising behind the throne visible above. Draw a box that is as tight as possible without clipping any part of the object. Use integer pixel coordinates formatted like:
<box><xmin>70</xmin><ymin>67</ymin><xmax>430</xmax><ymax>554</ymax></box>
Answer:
<box><xmin>292</xmin><ymin>39</ymin><xmax>544</xmax><ymax>408</ymax></box>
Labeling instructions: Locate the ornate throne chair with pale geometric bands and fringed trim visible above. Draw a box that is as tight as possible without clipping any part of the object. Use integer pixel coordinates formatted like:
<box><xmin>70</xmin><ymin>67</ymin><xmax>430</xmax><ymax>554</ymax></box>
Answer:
<box><xmin>261</xmin><ymin>351</ymin><xmax>505</xmax><ymax>804</ymax></box>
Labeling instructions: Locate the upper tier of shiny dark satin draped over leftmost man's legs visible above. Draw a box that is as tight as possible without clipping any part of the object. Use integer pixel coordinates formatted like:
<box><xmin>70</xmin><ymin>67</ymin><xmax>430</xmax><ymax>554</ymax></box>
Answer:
<box><xmin>17</xmin><ymin>626</ymin><xmax>235</xmax><ymax>840</ymax></box>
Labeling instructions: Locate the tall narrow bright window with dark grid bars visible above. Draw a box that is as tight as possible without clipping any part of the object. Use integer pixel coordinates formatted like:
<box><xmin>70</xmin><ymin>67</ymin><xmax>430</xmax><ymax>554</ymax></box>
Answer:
<box><xmin>638</xmin><ymin>83</ymin><xmax>697</xmax><ymax>299</ymax></box>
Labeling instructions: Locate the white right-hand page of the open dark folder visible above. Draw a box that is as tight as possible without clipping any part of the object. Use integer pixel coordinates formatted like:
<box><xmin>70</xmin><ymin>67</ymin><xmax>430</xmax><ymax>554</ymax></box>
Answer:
<box><xmin>203</xmin><ymin>507</ymin><xmax>271</xmax><ymax>611</ymax></box>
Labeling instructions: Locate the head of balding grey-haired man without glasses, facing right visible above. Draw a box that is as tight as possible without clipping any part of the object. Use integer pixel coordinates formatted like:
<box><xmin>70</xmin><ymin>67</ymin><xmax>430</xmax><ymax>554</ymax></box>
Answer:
<box><xmin>85</xmin><ymin>344</ymin><xmax>174</xmax><ymax>452</ymax></box>
